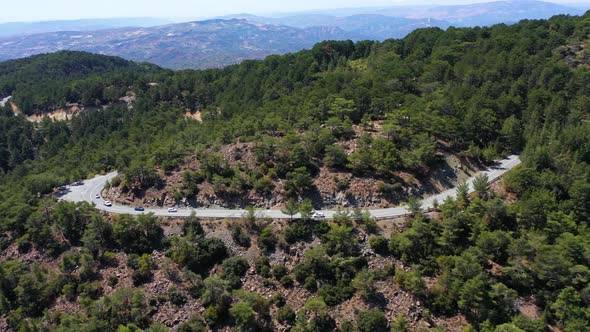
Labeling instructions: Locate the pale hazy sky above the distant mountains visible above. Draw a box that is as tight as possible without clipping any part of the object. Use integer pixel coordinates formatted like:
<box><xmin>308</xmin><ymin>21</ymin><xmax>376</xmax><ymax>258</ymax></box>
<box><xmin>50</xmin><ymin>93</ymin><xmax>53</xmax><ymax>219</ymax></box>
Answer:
<box><xmin>0</xmin><ymin>0</ymin><xmax>590</xmax><ymax>22</ymax></box>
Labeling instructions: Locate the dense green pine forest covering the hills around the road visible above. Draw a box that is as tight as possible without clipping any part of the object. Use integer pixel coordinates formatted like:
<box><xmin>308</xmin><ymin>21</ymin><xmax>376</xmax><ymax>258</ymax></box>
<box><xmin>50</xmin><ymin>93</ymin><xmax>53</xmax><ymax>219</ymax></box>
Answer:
<box><xmin>0</xmin><ymin>13</ymin><xmax>590</xmax><ymax>332</ymax></box>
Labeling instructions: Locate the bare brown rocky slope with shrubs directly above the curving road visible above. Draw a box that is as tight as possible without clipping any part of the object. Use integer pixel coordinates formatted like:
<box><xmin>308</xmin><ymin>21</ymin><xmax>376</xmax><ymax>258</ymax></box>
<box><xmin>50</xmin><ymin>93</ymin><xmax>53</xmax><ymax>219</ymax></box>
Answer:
<box><xmin>105</xmin><ymin>132</ymin><xmax>482</xmax><ymax>209</ymax></box>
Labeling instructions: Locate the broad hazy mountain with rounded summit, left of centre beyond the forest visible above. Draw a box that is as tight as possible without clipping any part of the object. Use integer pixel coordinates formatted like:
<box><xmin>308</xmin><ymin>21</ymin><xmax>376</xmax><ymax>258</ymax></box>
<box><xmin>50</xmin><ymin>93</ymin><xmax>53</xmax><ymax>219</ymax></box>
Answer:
<box><xmin>0</xmin><ymin>19</ymin><xmax>355</xmax><ymax>69</ymax></box>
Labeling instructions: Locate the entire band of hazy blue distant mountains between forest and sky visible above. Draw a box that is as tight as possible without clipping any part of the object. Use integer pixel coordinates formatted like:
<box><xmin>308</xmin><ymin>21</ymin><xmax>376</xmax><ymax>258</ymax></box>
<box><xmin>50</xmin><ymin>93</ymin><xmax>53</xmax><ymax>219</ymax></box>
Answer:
<box><xmin>0</xmin><ymin>0</ymin><xmax>584</xmax><ymax>69</ymax></box>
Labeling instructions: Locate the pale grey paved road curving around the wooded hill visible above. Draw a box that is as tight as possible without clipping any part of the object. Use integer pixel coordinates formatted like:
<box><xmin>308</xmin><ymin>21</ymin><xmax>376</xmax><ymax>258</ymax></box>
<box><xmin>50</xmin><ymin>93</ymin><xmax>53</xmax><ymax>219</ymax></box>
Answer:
<box><xmin>61</xmin><ymin>155</ymin><xmax>521</xmax><ymax>219</ymax></box>
